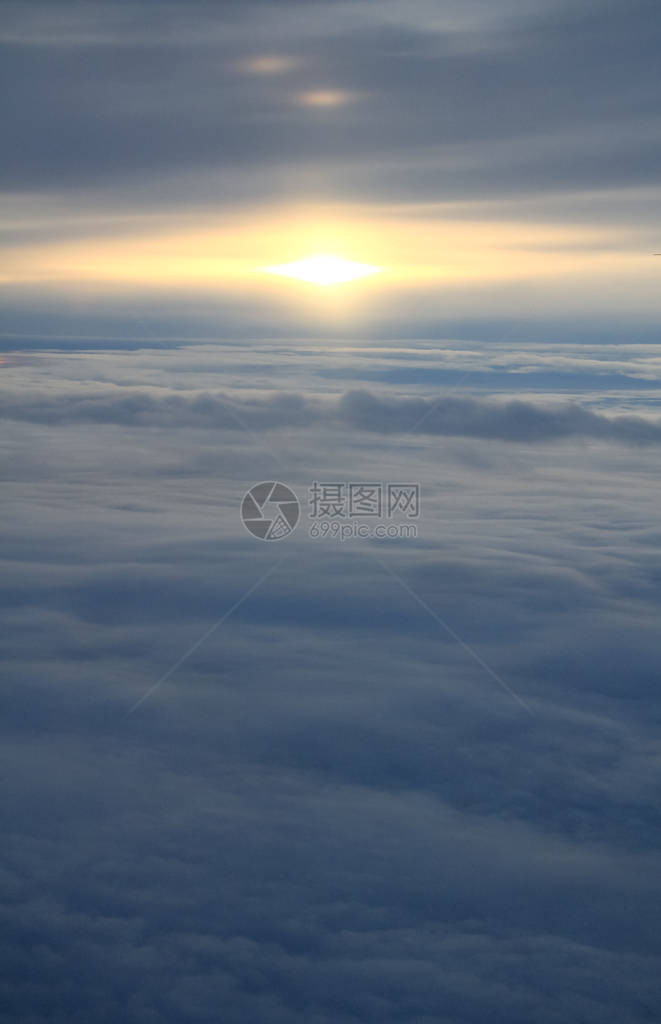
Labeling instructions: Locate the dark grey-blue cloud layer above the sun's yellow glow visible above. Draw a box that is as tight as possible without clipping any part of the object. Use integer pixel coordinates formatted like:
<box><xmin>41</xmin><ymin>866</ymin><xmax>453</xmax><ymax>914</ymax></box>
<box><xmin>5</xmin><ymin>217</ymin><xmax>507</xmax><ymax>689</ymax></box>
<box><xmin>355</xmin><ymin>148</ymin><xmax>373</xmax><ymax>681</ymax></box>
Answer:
<box><xmin>2</xmin><ymin>0</ymin><xmax>660</xmax><ymax>203</ymax></box>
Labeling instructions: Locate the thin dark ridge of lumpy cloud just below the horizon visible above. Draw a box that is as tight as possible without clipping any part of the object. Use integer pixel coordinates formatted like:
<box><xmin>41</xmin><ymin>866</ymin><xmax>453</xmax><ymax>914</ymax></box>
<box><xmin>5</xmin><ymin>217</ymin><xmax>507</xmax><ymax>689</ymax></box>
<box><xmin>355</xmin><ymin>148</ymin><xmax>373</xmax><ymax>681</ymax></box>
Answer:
<box><xmin>5</xmin><ymin>389</ymin><xmax>661</xmax><ymax>444</ymax></box>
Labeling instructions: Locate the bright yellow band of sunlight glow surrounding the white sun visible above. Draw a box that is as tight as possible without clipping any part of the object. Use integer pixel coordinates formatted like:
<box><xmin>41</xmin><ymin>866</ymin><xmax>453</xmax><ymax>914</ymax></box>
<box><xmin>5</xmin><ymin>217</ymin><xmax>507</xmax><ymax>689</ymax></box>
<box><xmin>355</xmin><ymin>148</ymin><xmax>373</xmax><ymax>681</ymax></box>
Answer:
<box><xmin>0</xmin><ymin>200</ymin><xmax>661</xmax><ymax>307</ymax></box>
